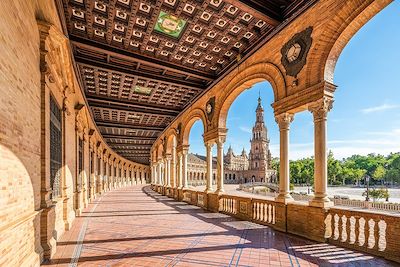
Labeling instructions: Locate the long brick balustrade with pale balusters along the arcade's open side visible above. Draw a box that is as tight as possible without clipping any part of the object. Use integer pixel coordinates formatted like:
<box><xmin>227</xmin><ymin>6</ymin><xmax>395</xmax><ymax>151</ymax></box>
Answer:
<box><xmin>152</xmin><ymin>185</ymin><xmax>400</xmax><ymax>262</ymax></box>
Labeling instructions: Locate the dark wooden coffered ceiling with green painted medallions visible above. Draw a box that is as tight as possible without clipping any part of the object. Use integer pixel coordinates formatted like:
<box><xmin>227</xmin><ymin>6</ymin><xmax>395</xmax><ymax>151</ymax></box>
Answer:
<box><xmin>56</xmin><ymin>0</ymin><xmax>315</xmax><ymax>164</ymax></box>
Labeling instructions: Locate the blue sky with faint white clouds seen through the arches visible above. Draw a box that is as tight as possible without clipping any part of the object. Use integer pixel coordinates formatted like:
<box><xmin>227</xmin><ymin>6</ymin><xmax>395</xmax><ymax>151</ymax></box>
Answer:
<box><xmin>189</xmin><ymin>1</ymin><xmax>400</xmax><ymax>159</ymax></box>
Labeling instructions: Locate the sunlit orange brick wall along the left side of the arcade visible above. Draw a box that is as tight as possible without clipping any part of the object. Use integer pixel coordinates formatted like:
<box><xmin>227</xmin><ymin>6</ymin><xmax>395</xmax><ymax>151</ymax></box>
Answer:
<box><xmin>0</xmin><ymin>0</ymin><xmax>150</xmax><ymax>266</ymax></box>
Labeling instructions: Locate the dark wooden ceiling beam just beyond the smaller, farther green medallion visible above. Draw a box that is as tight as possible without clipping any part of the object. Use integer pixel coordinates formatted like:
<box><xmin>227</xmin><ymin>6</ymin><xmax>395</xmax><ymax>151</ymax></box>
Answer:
<box><xmin>86</xmin><ymin>94</ymin><xmax>180</xmax><ymax>117</ymax></box>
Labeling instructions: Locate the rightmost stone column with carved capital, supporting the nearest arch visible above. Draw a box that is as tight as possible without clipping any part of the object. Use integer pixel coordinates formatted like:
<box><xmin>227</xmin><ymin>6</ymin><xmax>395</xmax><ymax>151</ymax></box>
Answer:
<box><xmin>308</xmin><ymin>97</ymin><xmax>333</xmax><ymax>207</ymax></box>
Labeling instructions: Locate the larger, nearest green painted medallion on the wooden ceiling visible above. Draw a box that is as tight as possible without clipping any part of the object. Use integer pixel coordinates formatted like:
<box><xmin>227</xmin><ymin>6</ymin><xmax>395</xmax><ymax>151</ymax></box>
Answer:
<box><xmin>154</xmin><ymin>11</ymin><xmax>186</xmax><ymax>38</ymax></box>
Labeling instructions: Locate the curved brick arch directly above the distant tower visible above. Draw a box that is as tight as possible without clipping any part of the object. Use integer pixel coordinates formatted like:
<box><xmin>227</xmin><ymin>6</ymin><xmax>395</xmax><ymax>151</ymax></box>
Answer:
<box><xmin>217</xmin><ymin>62</ymin><xmax>287</xmax><ymax>128</ymax></box>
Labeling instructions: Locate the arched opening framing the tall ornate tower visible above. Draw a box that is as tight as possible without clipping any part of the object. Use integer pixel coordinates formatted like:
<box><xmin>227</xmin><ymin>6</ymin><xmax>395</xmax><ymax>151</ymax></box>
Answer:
<box><xmin>220</xmin><ymin>79</ymin><xmax>279</xmax><ymax>193</ymax></box>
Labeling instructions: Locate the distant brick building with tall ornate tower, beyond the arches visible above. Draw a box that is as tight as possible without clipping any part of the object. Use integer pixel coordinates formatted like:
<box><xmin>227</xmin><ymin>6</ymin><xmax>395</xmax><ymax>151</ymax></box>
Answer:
<box><xmin>188</xmin><ymin>97</ymin><xmax>276</xmax><ymax>185</ymax></box>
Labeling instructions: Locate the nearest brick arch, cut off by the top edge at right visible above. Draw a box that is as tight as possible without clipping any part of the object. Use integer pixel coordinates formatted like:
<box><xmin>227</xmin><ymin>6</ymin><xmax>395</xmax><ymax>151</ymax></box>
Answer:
<box><xmin>306</xmin><ymin>0</ymin><xmax>392</xmax><ymax>87</ymax></box>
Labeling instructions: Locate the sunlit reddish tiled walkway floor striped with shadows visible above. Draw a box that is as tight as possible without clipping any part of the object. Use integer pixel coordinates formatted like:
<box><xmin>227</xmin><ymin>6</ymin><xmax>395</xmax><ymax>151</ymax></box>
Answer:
<box><xmin>44</xmin><ymin>186</ymin><xmax>395</xmax><ymax>267</ymax></box>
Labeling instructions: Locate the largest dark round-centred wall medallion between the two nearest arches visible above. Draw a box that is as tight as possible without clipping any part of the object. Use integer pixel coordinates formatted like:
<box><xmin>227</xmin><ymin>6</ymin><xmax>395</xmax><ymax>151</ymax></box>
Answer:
<box><xmin>281</xmin><ymin>27</ymin><xmax>313</xmax><ymax>77</ymax></box>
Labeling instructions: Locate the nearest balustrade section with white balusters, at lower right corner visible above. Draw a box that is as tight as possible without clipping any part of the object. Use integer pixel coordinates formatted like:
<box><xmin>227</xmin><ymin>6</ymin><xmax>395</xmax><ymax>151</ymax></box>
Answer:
<box><xmin>325</xmin><ymin>208</ymin><xmax>400</xmax><ymax>261</ymax></box>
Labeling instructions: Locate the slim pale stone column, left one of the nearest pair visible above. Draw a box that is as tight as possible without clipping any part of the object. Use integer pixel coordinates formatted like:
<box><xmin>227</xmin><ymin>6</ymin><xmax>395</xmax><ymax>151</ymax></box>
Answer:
<box><xmin>275</xmin><ymin>113</ymin><xmax>294</xmax><ymax>203</ymax></box>
